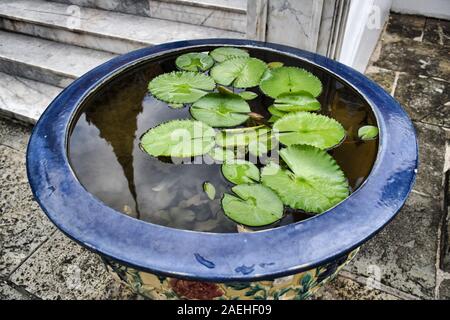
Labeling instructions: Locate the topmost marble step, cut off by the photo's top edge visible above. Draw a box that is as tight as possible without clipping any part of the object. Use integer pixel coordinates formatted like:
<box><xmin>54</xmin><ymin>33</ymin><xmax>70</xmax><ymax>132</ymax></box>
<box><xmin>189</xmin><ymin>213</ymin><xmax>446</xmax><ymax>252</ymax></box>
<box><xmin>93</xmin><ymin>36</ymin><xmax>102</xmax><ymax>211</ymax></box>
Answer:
<box><xmin>49</xmin><ymin>0</ymin><xmax>247</xmax><ymax>33</ymax></box>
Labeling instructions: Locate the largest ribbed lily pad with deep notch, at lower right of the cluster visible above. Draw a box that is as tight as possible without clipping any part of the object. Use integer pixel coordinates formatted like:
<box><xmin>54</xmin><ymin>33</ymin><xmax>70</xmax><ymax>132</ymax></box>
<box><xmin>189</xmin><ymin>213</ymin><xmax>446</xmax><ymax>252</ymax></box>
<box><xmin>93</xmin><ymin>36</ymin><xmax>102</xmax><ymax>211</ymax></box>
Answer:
<box><xmin>261</xmin><ymin>145</ymin><xmax>349</xmax><ymax>213</ymax></box>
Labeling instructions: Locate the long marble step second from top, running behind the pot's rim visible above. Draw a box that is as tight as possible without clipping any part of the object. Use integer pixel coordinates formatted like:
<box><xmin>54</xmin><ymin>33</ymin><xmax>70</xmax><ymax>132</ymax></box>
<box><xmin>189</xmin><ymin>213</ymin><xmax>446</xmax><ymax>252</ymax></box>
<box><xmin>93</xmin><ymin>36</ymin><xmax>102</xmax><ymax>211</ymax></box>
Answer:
<box><xmin>0</xmin><ymin>0</ymin><xmax>244</xmax><ymax>54</ymax></box>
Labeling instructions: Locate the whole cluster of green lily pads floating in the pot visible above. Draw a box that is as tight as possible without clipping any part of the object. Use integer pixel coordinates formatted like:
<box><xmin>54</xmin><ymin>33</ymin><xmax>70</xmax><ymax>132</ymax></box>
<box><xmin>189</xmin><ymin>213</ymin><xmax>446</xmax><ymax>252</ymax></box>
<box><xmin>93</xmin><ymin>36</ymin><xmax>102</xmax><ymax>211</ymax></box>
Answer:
<box><xmin>140</xmin><ymin>47</ymin><xmax>378</xmax><ymax>227</ymax></box>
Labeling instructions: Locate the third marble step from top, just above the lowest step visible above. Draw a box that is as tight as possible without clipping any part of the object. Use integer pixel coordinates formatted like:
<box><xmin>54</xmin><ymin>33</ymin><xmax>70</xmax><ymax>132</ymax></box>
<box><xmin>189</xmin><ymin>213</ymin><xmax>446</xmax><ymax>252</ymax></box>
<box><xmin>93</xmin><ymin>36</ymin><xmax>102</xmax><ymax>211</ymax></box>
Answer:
<box><xmin>0</xmin><ymin>31</ymin><xmax>115</xmax><ymax>88</ymax></box>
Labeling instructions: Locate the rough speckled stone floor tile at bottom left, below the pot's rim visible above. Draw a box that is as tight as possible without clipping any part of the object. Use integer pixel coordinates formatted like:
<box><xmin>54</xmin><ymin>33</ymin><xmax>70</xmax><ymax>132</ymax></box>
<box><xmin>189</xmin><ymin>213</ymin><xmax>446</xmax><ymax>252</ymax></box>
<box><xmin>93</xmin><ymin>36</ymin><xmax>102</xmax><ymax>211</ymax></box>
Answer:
<box><xmin>10</xmin><ymin>232</ymin><xmax>135</xmax><ymax>299</ymax></box>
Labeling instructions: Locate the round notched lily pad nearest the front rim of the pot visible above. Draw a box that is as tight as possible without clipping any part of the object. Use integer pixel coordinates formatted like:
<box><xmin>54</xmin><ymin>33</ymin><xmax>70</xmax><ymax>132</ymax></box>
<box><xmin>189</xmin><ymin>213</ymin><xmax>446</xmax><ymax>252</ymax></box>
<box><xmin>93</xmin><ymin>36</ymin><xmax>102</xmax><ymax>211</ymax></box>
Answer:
<box><xmin>222</xmin><ymin>184</ymin><xmax>283</xmax><ymax>227</ymax></box>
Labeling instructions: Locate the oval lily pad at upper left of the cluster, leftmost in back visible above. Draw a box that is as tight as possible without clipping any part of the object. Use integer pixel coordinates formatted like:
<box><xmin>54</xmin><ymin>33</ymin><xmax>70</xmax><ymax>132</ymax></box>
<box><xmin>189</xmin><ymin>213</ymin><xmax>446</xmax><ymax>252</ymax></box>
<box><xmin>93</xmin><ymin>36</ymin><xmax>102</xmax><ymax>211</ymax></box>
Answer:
<box><xmin>148</xmin><ymin>71</ymin><xmax>215</xmax><ymax>104</ymax></box>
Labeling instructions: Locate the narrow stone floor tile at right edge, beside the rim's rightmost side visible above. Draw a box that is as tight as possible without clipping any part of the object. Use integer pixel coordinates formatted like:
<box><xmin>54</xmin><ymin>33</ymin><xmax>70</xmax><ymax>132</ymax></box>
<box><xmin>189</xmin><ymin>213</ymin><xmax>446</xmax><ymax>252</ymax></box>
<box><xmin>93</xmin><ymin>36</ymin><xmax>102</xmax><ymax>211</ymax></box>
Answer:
<box><xmin>414</xmin><ymin>123</ymin><xmax>446</xmax><ymax>197</ymax></box>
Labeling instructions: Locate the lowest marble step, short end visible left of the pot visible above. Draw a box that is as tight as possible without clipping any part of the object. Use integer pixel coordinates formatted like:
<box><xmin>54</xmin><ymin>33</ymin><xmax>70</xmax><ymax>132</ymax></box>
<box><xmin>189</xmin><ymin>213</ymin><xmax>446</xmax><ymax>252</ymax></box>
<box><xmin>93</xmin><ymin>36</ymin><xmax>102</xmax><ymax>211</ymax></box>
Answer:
<box><xmin>0</xmin><ymin>72</ymin><xmax>62</xmax><ymax>124</ymax></box>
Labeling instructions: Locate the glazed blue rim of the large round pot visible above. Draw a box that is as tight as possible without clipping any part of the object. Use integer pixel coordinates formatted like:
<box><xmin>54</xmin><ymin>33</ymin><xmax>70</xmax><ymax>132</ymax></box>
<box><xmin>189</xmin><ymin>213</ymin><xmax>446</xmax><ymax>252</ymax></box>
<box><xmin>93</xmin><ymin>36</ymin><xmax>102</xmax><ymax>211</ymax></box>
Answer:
<box><xmin>27</xmin><ymin>39</ymin><xmax>418</xmax><ymax>282</ymax></box>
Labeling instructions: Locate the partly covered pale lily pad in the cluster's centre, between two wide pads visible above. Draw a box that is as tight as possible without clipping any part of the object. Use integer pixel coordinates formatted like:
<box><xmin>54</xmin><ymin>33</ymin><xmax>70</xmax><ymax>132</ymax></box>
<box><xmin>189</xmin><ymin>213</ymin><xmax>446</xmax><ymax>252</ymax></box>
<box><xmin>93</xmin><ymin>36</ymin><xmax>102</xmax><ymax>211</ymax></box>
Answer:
<box><xmin>216</xmin><ymin>125</ymin><xmax>270</xmax><ymax>148</ymax></box>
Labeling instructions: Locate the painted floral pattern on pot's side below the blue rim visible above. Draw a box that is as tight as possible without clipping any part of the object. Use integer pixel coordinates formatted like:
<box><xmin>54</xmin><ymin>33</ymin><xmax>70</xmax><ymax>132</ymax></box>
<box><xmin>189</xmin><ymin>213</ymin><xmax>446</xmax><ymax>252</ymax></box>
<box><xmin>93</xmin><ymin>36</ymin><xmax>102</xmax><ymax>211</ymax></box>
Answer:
<box><xmin>103</xmin><ymin>249</ymin><xmax>358</xmax><ymax>300</ymax></box>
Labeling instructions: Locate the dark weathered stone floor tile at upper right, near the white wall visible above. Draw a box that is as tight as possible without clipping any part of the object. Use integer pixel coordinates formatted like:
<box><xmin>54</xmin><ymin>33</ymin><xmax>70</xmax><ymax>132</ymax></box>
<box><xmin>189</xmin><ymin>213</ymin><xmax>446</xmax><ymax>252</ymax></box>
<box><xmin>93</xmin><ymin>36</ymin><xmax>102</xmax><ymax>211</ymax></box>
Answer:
<box><xmin>374</xmin><ymin>38</ymin><xmax>450</xmax><ymax>79</ymax></box>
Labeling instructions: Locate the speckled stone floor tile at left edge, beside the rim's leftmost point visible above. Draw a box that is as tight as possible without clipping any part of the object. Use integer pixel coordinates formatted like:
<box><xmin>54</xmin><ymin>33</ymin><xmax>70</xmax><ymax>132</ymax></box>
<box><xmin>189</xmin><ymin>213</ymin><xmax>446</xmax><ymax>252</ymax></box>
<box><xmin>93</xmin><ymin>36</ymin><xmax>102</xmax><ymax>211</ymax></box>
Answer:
<box><xmin>0</xmin><ymin>183</ymin><xmax>55</xmax><ymax>277</ymax></box>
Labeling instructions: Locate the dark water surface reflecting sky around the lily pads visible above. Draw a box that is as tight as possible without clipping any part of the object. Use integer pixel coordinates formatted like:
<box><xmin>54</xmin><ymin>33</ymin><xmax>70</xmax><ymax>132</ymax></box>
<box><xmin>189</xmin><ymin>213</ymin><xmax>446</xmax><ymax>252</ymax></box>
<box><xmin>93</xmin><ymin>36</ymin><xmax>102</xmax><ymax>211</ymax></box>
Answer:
<box><xmin>69</xmin><ymin>47</ymin><xmax>377</xmax><ymax>232</ymax></box>
